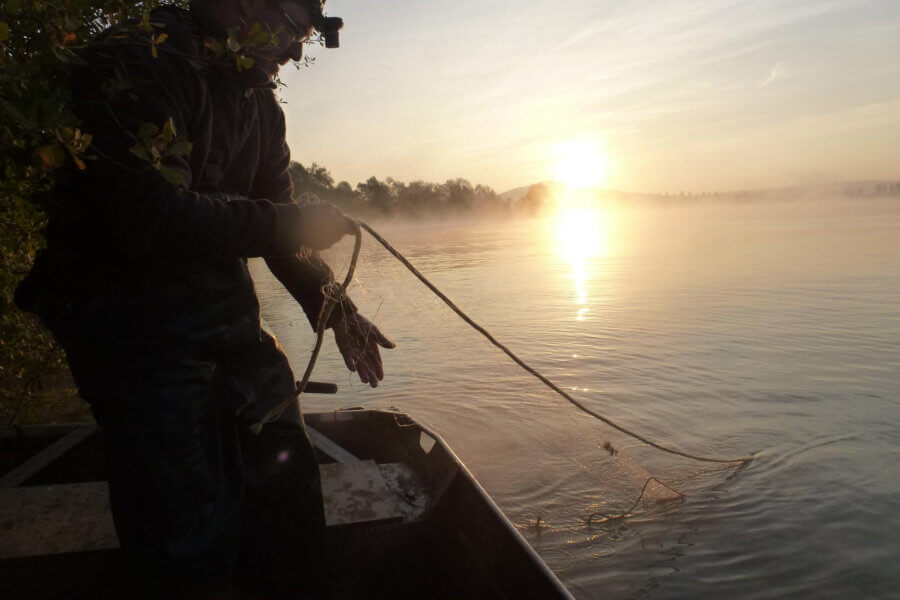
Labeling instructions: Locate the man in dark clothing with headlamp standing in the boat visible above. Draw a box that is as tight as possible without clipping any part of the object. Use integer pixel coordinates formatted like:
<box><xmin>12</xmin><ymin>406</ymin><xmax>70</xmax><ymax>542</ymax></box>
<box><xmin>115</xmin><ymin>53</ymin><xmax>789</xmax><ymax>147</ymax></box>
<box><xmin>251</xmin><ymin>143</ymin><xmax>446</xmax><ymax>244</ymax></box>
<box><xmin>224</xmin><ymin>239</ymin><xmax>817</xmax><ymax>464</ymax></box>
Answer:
<box><xmin>17</xmin><ymin>0</ymin><xmax>393</xmax><ymax>598</ymax></box>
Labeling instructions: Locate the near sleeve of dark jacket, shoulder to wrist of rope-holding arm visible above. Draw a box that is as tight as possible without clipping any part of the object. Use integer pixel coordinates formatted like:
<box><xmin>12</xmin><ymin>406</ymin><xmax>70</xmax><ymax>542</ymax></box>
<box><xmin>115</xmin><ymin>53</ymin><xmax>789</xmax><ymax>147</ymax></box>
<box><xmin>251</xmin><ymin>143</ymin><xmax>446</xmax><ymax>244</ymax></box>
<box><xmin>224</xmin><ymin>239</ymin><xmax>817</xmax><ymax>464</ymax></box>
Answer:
<box><xmin>73</xmin><ymin>28</ymin><xmax>301</xmax><ymax>260</ymax></box>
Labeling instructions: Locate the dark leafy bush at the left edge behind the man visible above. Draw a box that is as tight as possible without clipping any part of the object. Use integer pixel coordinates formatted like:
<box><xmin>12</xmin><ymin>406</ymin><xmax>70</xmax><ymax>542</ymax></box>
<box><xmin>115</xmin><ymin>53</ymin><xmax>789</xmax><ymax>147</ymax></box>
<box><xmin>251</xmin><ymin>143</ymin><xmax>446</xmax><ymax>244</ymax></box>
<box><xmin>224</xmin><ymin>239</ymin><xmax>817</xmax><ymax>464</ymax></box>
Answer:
<box><xmin>0</xmin><ymin>0</ymin><xmax>206</xmax><ymax>424</ymax></box>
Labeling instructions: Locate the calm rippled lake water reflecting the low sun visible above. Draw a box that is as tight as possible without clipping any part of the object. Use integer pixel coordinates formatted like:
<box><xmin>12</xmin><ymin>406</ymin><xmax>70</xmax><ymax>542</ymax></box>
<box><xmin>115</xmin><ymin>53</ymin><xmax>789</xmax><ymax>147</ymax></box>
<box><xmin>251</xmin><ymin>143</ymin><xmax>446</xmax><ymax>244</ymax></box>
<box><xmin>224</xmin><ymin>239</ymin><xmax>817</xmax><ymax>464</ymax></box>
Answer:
<box><xmin>254</xmin><ymin>199</ymin><xmax>900</xmax><ymax>599</ymax></box>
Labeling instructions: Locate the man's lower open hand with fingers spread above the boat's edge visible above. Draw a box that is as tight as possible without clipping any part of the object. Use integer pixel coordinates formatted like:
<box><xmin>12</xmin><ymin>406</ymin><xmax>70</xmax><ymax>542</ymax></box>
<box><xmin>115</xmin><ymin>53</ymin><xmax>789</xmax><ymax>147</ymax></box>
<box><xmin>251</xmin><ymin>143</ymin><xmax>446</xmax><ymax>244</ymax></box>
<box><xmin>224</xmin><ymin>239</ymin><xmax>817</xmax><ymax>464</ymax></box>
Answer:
<box><xmin>331</xmin><ymin>312</ymin><xmax>396</xmax><ymax>387</ymax></box>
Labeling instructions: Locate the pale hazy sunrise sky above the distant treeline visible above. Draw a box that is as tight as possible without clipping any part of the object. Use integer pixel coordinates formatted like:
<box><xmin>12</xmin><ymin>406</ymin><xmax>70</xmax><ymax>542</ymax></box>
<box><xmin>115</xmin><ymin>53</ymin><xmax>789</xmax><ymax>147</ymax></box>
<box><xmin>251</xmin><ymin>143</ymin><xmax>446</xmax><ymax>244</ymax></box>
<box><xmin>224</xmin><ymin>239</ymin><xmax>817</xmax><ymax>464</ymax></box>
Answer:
<box><xmin>282</xmin><ymin>0</ymin><xmax>900</xmax><ymax>192</ymax></box>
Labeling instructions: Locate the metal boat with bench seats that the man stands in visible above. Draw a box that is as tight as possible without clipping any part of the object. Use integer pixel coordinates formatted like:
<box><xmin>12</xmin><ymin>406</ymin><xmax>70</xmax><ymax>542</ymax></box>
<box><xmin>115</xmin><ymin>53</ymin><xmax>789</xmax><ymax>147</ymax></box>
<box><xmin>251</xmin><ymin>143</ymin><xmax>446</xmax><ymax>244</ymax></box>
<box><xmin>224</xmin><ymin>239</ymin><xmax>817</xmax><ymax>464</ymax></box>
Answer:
<box><xmin>0</xmin><ymin>409</ymin><xmax>572</xmax><ymax>600</ymax></box>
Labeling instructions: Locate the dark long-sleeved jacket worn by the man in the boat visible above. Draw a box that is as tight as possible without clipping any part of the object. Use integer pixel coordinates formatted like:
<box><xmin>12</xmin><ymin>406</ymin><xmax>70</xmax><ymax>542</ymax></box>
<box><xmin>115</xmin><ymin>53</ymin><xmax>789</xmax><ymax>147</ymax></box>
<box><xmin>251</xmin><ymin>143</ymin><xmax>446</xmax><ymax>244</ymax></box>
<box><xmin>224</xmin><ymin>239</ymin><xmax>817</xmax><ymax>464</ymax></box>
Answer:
<box><xmin>18</xmin><ymin>8</ymin><xmax>349</xmax><ymax>366</ymax></box>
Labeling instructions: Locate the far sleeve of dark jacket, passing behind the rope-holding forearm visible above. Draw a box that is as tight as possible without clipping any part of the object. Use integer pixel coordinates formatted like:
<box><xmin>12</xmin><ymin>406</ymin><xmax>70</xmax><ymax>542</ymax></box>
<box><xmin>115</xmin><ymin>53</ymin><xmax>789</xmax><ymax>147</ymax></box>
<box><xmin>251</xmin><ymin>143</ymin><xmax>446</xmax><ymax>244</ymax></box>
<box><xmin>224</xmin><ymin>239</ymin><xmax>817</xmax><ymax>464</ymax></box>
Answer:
<box><xmin>252</xmin><ymin>99</ymin><xmax>356</xmax><ymax>328</ymax></box>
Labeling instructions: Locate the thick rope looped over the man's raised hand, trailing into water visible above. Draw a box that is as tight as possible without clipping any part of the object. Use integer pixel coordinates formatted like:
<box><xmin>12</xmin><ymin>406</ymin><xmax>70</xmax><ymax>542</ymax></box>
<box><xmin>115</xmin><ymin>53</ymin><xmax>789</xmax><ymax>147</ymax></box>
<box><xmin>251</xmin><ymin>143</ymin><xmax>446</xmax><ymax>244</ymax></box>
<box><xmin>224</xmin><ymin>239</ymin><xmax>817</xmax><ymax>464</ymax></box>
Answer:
<box><xmin>254</xmin><ymin>221</ymin><xmax>753</xmax><ymax>463</ymax></box>
